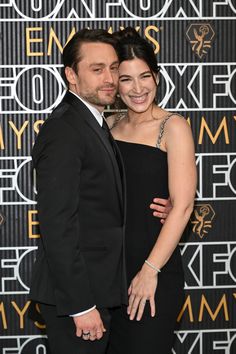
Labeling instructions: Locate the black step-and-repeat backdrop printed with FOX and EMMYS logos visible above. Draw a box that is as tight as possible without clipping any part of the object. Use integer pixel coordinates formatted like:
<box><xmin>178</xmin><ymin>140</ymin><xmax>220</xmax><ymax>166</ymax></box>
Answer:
<box><xmin>0</xmin><ymin>0</ymin><xmax>236</xmax><ymax>354</ymax></box>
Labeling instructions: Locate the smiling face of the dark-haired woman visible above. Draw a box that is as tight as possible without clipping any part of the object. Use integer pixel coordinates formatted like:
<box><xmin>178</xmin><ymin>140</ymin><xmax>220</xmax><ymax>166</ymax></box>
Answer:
<box><xmin>119</xmin><ymin>58</ymin><xmax>157</xmax><ymax>113</ymax></box>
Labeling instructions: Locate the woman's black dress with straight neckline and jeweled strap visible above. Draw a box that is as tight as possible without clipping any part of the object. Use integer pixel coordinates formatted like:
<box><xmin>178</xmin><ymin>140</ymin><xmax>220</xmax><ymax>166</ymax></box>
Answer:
<box><xmin>107</xmin><ymin>121</ymin><xmax>184</xmax><ymax>354</ymax></box>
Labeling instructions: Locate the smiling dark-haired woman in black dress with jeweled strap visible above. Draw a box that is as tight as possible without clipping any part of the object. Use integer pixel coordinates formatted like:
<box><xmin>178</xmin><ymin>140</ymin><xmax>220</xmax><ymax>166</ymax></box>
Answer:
<box><xmin>108</xmin><ymin>28</ymin><xmax>196</xmax><ymax>354</ymax></box>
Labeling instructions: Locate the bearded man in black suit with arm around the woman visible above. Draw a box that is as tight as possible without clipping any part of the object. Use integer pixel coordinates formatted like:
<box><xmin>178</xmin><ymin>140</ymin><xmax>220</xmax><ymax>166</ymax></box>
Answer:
<box><xmin>30</xmin><ymin>29</ymin><xmax>170</xmax><ymax>354</ymax></box>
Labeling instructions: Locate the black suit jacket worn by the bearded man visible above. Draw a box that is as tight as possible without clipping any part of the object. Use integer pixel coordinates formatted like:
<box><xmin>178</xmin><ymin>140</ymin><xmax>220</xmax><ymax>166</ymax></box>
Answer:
<box><xmin>30</xmin><ymin>92</ymin><xmax>127</xmax><ymax>315</ymax></box>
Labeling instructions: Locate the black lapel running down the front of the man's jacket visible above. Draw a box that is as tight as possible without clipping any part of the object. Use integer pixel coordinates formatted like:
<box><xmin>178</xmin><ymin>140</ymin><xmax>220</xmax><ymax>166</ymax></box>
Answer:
<box><xmin>64</xmin><ymin>92</ymin><xmax>125</xmax><ymax>209</ymax></box>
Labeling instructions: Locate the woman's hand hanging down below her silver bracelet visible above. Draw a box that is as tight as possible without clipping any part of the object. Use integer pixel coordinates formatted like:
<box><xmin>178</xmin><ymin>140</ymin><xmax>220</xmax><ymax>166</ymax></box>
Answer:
<box><xmin>127</xmin><ymin>264</ymin><xmax>157</xmax><ymax>321</ymax></box>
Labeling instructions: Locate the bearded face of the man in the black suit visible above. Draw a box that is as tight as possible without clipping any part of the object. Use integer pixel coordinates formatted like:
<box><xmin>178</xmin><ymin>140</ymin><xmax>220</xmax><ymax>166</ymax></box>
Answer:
<box><xmin>66</xmin><ymin>43</ymin><xmax>119</xmax><ymax>111</ymax></box>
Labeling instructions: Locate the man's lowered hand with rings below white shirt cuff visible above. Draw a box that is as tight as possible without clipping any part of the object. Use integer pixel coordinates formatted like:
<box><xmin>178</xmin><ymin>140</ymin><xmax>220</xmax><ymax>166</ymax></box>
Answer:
<box><xmin>73</xmin><ymin>309</ymin><xmax>106</xmax><ymax>341</ymax></box>
